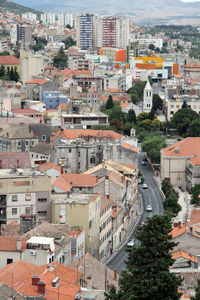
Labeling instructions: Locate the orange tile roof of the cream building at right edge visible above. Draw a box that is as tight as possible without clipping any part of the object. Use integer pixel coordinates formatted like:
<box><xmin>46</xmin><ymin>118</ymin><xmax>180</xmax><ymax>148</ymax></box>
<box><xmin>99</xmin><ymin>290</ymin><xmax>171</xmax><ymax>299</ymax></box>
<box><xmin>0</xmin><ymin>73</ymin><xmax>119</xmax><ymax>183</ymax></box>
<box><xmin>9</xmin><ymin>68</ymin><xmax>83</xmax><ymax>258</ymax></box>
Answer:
<box><xmin>161</xmin><ymin>137</ymin><xmax>200</xmax><ymax>157</ymax></box>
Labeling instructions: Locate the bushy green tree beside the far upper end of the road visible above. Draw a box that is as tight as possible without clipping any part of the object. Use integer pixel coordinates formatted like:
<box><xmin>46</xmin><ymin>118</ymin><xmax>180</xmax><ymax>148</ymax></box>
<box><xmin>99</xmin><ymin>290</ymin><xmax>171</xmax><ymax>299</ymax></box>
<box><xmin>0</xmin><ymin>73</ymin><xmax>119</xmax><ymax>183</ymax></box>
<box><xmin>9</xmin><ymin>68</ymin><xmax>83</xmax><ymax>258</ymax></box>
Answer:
<box><xmin>142</xmin><ymin>135</ymin><xmax>166</xmax><ymax>163</ymax></box>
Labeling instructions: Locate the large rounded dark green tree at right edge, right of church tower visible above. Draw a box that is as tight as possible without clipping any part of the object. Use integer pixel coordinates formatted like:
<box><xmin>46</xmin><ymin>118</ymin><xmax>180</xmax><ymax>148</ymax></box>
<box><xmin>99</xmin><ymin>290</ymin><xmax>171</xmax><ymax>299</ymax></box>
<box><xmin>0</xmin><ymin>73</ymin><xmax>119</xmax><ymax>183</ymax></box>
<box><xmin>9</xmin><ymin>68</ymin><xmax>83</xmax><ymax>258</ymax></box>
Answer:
<box><xmin>171</xmin><ymin>108</ymin><xmax>199</xmax><ymax>135</ymax></box>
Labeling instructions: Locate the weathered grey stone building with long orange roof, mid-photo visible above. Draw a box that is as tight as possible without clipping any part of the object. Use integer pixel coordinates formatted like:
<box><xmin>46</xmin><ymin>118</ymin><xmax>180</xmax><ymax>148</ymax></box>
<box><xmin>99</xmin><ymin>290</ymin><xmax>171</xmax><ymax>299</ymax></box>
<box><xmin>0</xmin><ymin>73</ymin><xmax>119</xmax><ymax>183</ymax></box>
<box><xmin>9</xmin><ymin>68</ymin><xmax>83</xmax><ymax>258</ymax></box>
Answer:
<box><xmin>51</xmin><ymin>129</ymin><xmax>138</xmax><ymax>174</ymax></box>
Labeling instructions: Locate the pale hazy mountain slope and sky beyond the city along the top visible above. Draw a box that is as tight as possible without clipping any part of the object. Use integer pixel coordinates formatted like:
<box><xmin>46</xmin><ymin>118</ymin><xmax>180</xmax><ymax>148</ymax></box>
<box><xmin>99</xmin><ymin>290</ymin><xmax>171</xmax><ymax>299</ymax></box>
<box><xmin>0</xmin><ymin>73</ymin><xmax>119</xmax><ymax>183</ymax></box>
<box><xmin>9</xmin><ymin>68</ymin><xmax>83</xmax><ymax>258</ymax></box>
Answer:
<box><xmin>13</xmin><ymin>0</ymin><xmax>200</xmax><ymax>25</ymax></box>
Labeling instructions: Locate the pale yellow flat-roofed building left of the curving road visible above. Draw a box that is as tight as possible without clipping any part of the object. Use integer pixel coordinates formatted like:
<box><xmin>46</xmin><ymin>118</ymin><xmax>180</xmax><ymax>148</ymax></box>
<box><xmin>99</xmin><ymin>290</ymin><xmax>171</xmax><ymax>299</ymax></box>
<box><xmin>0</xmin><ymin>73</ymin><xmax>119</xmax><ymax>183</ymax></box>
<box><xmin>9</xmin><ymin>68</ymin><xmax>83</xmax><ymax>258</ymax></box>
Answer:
<box><xmin>51</xmin><ymin>193</ymin><xmax>101</xmax><ymax>258</ymax></box>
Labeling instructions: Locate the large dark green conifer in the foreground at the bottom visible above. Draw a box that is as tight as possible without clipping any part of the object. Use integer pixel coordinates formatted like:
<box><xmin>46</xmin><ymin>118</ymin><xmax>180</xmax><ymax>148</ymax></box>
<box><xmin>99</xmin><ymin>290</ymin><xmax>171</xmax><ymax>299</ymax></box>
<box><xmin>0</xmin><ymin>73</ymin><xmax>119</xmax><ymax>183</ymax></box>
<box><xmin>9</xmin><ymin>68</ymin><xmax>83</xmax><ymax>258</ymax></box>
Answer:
<box><xmin>106</xmin><ymin>215</ymin><xmax>181</xmax><ymax>300</ymax></box>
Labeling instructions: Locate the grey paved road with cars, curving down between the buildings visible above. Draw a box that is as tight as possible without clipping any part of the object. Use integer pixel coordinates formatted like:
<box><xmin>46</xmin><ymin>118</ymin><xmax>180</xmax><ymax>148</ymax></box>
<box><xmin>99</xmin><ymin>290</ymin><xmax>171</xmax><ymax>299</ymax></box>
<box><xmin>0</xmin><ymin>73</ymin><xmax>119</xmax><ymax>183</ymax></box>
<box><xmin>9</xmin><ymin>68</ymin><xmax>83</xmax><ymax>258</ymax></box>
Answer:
<box><xmin>107</xmin><ymin>152</ymin><xmax>163</xmax><ymax>273</ymax></box>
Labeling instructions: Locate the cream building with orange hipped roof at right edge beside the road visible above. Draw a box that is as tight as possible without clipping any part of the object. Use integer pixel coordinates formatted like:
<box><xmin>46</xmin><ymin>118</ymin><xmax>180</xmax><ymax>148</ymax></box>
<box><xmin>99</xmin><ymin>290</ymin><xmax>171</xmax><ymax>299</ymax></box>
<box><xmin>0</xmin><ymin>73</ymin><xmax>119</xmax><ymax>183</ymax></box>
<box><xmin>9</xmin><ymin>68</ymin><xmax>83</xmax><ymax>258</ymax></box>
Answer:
<box><xmin>160</xmin><ymin>137</ymin><xmax>200</xmax><ymax>187</ymax></box>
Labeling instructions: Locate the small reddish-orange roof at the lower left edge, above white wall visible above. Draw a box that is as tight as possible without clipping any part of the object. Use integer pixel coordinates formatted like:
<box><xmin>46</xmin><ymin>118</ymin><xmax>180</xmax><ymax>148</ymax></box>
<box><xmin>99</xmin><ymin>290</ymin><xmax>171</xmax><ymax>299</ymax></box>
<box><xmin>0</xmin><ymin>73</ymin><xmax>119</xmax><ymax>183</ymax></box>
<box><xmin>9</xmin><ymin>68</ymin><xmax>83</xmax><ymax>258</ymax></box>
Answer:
<box><xmin>0</xmin><ymin>236</ymin><xmax>27</xmax><ymax>251</ymax></box>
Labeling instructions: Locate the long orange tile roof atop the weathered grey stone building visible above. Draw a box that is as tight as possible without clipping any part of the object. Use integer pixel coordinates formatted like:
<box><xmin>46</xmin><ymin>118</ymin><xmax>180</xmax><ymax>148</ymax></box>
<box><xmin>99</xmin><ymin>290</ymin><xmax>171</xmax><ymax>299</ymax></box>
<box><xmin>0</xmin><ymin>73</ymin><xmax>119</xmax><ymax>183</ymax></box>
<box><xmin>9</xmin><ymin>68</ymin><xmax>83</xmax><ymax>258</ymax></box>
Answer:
<box><xmin>51</xmin><ymin>129</ymin><xmax>123</xmax><ymax>141</ymax></box>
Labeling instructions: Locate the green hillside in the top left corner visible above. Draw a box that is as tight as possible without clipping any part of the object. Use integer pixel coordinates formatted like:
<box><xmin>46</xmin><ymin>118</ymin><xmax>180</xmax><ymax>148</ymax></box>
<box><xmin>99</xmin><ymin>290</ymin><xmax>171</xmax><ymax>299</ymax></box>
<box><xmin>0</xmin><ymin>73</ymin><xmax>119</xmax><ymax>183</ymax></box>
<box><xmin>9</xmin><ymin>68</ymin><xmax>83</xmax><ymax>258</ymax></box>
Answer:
<box><xmin>0</xmin><ymin>0</ymin><xmax>40</xmax><ymax>15</ymax></box>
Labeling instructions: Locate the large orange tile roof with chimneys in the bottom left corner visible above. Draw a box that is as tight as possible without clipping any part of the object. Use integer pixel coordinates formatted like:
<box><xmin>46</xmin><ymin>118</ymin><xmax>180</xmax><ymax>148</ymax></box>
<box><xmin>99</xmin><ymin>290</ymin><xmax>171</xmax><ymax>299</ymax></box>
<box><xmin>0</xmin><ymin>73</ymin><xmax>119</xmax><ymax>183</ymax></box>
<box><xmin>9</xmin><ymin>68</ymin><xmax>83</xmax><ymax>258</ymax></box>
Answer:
<box><xmin>0</xmin><ymin>260</ymin><xmax>82</xmax><ymax>300</ymax></box>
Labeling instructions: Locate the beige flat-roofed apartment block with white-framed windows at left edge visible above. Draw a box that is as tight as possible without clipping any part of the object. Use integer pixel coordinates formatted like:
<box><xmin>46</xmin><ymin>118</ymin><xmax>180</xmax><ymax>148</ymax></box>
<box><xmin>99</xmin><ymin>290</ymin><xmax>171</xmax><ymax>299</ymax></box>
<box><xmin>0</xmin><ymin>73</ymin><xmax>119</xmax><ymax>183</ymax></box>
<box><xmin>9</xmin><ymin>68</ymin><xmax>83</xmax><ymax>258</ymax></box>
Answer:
<box><xmin>0</xmin><ymin>168</ymin><xmax>51</xmax><ymax>224</ymax></box>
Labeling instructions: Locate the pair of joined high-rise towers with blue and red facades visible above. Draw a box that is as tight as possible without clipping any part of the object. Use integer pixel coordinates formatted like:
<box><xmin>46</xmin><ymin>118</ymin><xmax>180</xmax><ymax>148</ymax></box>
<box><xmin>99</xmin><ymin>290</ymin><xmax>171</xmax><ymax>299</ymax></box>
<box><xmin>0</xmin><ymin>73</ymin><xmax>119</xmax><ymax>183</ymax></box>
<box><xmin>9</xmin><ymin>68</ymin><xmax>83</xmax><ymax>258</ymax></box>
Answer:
<box><xmin>76</xmin><ymin>14</ymin><xmax>129</xmax><ymax>50</ymax></box>
